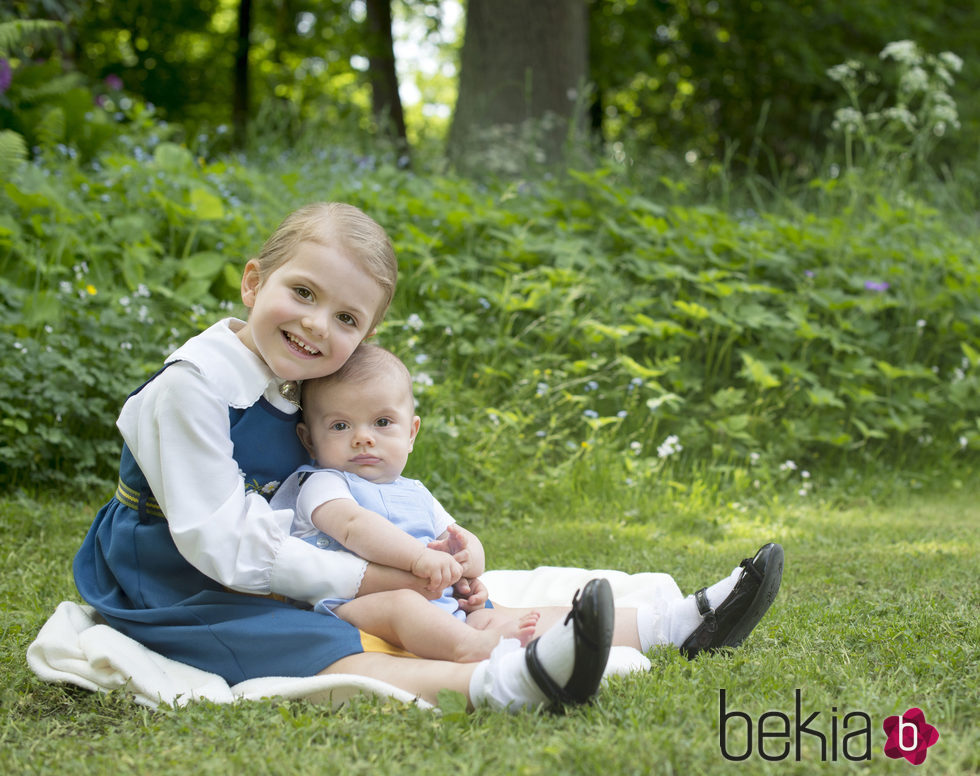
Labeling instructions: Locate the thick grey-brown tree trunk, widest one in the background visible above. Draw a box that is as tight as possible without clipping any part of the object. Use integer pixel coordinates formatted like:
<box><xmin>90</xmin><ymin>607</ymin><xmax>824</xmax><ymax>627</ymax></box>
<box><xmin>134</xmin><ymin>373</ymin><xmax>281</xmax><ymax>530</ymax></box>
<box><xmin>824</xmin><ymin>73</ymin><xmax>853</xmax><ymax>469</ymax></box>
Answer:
<box><xmin>449</xmin><ymin>0</ymin><xmax>589</xmax><ymax>167</ymax></box>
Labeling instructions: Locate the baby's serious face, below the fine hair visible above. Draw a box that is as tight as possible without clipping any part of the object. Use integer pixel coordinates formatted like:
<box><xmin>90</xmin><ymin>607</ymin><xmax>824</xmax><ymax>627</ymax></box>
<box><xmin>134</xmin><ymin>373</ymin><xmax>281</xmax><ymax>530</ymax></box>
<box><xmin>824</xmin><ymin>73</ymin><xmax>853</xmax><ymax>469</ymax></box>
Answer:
<box><xmin>300</xmin><ymin>377</ymin><xmax>419</xmax><ymax>482</ymax></box>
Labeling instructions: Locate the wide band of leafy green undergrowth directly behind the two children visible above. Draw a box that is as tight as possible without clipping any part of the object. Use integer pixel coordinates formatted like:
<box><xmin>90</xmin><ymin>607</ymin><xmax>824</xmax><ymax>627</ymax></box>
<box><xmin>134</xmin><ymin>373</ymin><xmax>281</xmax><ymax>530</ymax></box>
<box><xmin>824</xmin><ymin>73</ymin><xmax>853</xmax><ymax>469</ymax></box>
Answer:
<box><xmin>0</xmin><ymin>56</ymin><xmax>980</xmax><ymax>492</ymax></box>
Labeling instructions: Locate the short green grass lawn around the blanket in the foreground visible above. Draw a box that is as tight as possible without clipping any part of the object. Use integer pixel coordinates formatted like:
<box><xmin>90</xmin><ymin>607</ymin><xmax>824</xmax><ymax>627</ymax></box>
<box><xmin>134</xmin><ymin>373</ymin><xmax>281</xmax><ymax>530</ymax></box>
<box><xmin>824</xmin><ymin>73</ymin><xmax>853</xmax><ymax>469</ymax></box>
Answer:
<box><xmin>0</xmin><ymin>476</ymin><xmax>980</xmax><ymax>776</ymax></box>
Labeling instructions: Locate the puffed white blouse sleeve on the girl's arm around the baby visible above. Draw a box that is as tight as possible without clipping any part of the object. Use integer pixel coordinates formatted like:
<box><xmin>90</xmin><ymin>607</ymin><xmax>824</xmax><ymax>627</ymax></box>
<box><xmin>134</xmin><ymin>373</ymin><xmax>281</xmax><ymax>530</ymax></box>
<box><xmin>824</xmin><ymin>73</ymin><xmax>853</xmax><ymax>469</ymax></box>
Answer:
<box><xmin>118</xmin><ymin>362</ymin><xmax>366</xmax><ymax>604</ymax></box>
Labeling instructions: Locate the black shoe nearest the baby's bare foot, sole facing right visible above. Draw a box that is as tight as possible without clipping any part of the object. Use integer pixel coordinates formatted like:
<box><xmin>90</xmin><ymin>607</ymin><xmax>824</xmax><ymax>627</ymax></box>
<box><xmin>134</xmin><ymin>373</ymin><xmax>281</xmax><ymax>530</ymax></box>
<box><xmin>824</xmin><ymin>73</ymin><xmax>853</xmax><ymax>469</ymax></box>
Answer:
<box><xmin>524</xmin><ymin>579</ymin><xmax>616</xmax><ymax>710</ymax></box>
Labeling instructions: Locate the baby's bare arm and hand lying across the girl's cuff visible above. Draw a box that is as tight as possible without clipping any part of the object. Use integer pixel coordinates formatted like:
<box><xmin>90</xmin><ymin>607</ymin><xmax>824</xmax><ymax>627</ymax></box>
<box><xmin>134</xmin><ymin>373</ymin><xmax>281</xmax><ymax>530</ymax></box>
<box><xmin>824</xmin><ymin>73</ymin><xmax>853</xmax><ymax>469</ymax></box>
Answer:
<box><xmin>312</xmin><ymin>498</ymin><xmax>462</xmax><ymax>591</ymax></box>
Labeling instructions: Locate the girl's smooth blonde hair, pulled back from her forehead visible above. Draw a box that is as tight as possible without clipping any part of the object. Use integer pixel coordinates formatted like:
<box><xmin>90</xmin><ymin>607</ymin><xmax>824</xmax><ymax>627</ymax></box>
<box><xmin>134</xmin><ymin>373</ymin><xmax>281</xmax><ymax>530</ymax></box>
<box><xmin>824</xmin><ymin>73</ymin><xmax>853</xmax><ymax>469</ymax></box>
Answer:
<box><xmin>255</xmin><ymin>202</ymin><xmax>398</xmax><ymax>328</ymax></box>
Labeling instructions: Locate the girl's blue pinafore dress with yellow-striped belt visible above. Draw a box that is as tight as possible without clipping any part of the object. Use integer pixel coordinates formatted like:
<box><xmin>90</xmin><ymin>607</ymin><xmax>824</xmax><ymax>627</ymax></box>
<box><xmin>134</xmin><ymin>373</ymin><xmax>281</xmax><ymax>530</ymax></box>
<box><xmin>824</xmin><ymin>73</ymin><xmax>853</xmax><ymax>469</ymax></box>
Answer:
<box><xmin>73</xmin><ymin>365</ymin><xmax>363</xmax><ymax>684</ymax></box>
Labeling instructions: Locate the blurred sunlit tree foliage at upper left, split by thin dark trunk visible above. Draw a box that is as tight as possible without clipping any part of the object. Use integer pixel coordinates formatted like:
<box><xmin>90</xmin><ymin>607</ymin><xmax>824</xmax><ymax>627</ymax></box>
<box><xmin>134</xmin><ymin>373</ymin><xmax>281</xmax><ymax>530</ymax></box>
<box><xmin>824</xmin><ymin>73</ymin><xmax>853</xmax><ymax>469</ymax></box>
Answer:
<box><xmin>72</xmin><ymin>0</ymin><xmax>370</xmax><ymax>142</ymax></box>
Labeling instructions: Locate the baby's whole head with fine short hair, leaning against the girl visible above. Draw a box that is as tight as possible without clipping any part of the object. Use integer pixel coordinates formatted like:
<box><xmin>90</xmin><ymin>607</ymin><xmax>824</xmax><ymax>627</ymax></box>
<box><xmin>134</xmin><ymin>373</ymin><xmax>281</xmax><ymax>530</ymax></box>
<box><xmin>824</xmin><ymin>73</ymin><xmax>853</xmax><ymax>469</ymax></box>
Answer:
<box><xmin>297</xmin><ymin>343</ymin><xmax>420</xmax><ymax>483</ymax></box>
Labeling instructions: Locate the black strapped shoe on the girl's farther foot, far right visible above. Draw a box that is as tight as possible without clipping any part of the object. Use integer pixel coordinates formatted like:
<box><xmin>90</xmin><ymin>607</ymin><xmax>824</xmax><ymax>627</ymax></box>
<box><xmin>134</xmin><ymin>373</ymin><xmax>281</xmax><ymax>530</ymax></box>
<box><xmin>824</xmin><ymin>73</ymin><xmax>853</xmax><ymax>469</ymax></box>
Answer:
<box><xmin>681</xmin><ymin>542</ymin><xmax>783</xmax><ymax>660</ymax></box>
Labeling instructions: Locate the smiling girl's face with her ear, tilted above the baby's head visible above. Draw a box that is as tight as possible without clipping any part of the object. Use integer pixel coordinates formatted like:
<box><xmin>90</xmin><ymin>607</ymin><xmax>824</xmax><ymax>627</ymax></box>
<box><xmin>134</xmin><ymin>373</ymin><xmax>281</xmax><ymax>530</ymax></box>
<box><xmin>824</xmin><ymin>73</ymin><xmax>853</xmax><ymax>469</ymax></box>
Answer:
<box><xmin>238</xmin><ymin>242</ymin><xmax>384</xmax><ymax>380</ymax></box>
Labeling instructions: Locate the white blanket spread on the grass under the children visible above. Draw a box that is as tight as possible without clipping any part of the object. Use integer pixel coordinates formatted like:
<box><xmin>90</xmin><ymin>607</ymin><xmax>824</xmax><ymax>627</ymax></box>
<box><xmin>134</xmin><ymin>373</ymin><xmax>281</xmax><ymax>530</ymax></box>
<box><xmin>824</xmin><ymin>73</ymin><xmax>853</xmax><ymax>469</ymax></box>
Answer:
<box><xmin>27</xmin><ymin>566</ymin><xmax>681</xmax><ymax>707</ymax></box>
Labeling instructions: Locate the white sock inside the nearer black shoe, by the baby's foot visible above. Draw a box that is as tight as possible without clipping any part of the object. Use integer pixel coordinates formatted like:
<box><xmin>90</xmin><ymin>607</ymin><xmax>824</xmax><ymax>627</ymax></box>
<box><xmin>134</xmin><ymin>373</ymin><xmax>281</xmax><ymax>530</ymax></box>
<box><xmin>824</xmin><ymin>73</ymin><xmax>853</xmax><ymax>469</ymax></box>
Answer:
<box><xmin>470</xmin><ymin>608</ymin><xmax>575</xmax><ymax>712</ymax></box>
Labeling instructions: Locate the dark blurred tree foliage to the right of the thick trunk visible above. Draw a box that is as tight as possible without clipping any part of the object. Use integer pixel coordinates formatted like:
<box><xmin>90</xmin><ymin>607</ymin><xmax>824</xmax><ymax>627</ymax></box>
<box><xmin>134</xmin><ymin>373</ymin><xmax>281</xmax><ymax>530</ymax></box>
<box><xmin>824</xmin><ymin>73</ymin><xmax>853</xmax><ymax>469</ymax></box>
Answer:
<box><xmin>591</xmin><ymin>0</ymin><xmax>980</xmax><ymax>171</ymax></box>
